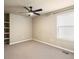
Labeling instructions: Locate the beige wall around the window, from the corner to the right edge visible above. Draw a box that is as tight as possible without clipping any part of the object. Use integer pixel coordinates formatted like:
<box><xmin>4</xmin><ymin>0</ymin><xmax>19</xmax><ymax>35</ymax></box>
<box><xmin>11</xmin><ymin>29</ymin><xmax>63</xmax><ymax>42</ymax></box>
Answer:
<box><xmin>33</xmin><ymin>14</ymin><xmax>74</xmax><ymax>51</ymax></box>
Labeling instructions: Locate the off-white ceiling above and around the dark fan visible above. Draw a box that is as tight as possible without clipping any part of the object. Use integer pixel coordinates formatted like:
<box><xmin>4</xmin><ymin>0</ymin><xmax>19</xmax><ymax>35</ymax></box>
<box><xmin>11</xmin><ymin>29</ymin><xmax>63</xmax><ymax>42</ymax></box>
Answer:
<box><xmin>4</xmin><ymin>0</ymin><xmax>73</xmax><ymax>13</ymax></box>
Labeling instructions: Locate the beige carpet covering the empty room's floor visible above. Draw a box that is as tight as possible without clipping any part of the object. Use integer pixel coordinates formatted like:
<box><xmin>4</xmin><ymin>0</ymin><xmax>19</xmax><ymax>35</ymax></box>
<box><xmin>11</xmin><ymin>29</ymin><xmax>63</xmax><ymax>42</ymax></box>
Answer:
<box><xmin>4</xmin><ymin>41</ymin><xmax>74</xmax><ymax>59</ymax></box>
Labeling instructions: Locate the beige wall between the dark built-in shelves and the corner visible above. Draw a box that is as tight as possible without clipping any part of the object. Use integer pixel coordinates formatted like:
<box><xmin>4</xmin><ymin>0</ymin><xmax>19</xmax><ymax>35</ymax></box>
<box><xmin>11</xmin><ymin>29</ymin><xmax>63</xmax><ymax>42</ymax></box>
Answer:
<box><xmin>10</xmin><ymin>14</ymin><xmax>32</xmax><ymax>44</ymax></box>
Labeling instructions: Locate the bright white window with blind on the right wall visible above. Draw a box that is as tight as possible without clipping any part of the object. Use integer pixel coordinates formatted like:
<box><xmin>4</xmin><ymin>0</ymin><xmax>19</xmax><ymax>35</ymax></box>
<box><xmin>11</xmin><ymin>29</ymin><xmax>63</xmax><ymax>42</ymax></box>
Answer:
<box><xmin>57</xmin><ymin>11</ymin><xmax>74</xmax><ymax>41</ymax></box>
